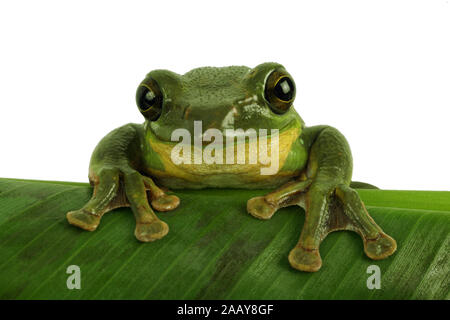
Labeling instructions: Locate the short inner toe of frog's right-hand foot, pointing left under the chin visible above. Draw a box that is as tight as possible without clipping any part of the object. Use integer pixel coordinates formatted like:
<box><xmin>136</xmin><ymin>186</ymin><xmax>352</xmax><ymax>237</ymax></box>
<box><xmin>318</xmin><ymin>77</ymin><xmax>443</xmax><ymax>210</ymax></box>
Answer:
<box><xmin>247</xmin><ymin>180</ymin><xmax>311</xmax><ymax>220</ymax></box>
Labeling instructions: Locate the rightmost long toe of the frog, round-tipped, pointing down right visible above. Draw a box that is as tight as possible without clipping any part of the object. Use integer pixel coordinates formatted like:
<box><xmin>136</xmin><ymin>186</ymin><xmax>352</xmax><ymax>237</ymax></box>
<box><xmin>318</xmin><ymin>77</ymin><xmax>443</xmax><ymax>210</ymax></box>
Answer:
<box><xmin>336</xmin><ymin>185</ymin><xmax>397</xmax><ymax>260</ymax></box>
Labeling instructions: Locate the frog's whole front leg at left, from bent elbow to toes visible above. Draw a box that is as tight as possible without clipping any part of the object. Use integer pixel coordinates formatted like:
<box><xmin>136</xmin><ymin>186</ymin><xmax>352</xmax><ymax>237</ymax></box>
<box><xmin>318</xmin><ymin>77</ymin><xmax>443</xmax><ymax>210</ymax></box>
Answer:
<box><xmin>67</xmin><ymin>125</ymin><xmax>179</xmax><ymax>242</ymax></box>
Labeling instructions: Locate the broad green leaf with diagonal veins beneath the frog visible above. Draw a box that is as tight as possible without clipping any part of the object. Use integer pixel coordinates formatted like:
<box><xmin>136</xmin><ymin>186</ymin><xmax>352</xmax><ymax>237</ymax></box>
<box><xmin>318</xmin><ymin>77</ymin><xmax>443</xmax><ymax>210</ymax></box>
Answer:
<box><xmin>0</xmin><ymin>179</ymin><xmax>450</xmax><ymax>299</ymax></box>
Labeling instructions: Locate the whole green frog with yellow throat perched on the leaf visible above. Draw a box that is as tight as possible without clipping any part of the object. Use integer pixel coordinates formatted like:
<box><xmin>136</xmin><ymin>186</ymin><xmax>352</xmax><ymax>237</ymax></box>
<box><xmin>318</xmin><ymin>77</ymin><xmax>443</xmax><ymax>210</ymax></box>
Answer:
<box><xmin>67</xmin><ymin>62</ymin><xmax>397</xmax><ymax>272</ymax></box>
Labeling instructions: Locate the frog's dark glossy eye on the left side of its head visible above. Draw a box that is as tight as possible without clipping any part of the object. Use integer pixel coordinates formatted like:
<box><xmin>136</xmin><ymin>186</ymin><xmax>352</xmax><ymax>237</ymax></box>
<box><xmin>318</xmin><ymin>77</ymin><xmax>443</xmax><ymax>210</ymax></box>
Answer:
<box><xmin>136</xmin><ymin>79</ymin><xmax>163</xmax><ymax>121</ymax></box>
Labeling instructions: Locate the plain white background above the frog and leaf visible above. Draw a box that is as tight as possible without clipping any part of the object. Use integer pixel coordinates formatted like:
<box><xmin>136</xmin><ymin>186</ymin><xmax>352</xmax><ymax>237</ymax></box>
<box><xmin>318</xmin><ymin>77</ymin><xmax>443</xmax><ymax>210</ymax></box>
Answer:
<box><xmin>0</xmin><ymin>0</ymin><xmax>450</xmax><ymax>190</ymax></box>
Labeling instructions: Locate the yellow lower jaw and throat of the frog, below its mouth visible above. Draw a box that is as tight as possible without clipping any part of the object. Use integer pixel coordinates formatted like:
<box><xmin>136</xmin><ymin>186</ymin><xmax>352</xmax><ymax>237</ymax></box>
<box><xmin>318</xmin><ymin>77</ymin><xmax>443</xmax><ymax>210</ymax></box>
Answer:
<box><xmin>147</xmin><ymin>117</ymin><xmax>301</xmax><ymax>178</ymax></box>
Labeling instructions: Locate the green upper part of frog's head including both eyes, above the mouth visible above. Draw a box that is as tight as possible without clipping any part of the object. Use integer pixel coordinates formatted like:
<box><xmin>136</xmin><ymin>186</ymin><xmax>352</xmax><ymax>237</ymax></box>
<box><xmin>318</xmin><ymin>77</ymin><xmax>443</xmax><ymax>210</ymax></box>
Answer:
<box><xmin>136</xmin><ymin>63</ymin><xmax>303</xmax><ymax>141</ymax></box>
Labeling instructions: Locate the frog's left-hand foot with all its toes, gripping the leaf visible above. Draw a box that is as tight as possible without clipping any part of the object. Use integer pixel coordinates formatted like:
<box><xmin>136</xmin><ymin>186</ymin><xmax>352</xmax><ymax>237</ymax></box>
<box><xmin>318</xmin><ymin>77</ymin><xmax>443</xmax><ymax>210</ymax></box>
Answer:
<box><xmin>67</xmin><ymin>168</ymin><xmax>180</xmax><ymax>242</ymax></box>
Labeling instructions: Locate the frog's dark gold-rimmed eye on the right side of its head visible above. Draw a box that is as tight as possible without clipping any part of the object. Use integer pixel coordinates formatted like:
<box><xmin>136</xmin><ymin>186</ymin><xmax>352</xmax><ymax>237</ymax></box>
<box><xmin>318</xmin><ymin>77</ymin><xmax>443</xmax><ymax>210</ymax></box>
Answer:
<box><xmin>264</xmin><ymin>71</ymin><xmax>295</xmax><ymax>114</ymax></box>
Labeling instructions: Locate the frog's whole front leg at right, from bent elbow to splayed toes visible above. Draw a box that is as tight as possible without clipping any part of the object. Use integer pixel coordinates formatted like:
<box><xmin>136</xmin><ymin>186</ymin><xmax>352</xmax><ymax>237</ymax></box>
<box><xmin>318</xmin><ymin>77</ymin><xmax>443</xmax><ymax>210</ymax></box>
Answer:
<box><xmin>247</xmin><ymin>127</ymin><xmax>397</xmax><ymax>272</ymax></box>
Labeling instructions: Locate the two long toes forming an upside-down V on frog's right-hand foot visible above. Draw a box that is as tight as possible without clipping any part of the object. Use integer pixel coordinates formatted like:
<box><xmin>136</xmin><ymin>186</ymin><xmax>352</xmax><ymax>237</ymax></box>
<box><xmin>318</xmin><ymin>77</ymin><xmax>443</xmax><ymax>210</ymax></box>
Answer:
<box><xmin>289</xmin><ymin>184</ymin><xmax>397</xmax><ymax>272</ymax></box>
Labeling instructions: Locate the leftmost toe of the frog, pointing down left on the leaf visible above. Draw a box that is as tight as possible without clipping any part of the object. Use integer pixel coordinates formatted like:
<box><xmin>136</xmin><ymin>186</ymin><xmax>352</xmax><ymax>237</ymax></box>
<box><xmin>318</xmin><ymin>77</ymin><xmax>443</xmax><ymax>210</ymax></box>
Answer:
<box><xmin>67</xmin><ymin>168</ymin><xmax>122</xmax><ymax>231</ymax></box>
